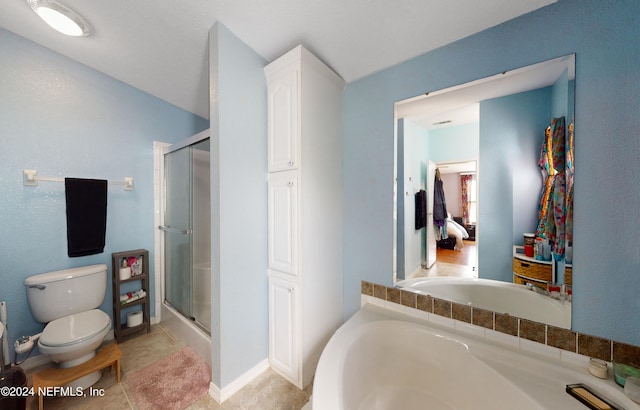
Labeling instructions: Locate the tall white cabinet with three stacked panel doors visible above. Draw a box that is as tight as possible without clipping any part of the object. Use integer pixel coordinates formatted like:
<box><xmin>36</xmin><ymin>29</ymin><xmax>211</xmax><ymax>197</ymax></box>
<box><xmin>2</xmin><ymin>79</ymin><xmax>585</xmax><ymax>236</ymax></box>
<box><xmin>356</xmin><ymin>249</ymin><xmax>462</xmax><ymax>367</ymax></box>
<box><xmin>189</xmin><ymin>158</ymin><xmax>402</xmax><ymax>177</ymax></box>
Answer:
<box><xmin>265</xmin><ymin>46</ymin><xmax>344</xmax><ymax>388</ymax></box>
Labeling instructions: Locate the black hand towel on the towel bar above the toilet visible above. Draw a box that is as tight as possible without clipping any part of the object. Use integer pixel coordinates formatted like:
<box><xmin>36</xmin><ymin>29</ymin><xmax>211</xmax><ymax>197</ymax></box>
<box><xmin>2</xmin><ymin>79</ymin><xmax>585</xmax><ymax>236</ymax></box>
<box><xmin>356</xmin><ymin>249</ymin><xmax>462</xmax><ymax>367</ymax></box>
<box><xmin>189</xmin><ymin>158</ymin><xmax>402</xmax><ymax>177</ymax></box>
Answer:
<box><xmin>64</xmin><ymin>178</ymin><xmax>107</xmax><ymax>258</ymax></box>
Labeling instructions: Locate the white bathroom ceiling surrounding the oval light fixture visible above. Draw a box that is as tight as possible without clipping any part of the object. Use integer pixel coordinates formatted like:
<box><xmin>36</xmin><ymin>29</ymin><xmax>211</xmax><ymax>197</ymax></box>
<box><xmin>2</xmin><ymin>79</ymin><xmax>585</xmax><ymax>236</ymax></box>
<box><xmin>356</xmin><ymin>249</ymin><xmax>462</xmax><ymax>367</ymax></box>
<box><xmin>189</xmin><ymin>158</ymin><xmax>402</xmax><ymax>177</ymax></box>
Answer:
<box><xmin>0</xmin><ymin>0</ymin><xmax>556</xmax><ymax>118</ymax></box>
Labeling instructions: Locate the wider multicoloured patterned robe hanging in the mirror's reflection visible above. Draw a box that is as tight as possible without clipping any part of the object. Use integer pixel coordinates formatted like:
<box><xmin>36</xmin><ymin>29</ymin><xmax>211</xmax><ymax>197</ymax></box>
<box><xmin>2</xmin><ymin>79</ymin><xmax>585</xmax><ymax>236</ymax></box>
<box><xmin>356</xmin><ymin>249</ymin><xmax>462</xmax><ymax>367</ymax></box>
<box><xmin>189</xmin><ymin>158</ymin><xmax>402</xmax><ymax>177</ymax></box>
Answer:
<box><xmin>536</xmin><ymin>117</ymin><xmax>566</xmax><ymax>258</ymax></box>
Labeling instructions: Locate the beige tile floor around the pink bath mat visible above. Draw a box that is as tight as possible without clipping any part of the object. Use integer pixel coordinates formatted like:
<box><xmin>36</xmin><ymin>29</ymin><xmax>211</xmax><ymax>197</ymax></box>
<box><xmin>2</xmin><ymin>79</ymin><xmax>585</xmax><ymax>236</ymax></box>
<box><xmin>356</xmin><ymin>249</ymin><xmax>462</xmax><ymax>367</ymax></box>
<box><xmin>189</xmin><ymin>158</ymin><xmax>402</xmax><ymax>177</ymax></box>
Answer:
<box><xmin>27</xmin><ymin>324</ymin><xmax>311</xmax><ymax>410</ymax></box>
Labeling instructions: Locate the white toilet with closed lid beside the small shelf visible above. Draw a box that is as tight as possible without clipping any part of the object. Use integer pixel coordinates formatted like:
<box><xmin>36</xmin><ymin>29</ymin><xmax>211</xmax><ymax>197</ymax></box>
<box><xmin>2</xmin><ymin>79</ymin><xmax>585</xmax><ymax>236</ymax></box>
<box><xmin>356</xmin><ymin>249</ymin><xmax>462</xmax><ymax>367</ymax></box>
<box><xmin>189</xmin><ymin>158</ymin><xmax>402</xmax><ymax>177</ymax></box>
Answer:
<box><xmin>24</xmin><ymin>264</ymin><xmax>111</xmax><ymax>388</ymax></box>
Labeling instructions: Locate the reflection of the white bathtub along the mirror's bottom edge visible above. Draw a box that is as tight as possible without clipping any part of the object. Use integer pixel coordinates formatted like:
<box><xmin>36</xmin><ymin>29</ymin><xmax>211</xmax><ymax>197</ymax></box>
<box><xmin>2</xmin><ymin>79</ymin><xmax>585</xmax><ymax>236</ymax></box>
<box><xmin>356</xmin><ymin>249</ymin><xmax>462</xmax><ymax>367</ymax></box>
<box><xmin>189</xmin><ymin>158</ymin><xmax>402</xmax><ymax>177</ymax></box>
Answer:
<box><xmin>396</xmin><ymin>277</ymin><xmax>571</xmax><ymax>329</ymax></box>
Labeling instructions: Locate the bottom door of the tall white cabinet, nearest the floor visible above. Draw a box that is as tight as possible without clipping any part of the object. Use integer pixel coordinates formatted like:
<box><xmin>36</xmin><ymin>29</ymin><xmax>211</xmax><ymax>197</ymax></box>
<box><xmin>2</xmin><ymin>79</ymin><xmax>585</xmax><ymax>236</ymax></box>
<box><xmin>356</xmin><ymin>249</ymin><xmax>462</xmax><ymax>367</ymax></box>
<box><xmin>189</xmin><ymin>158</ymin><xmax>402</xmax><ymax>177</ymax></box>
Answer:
<box><xmin>269</xmin><ymin>278</ymin><xmax>299</xmax><ymax>385</ymax></box>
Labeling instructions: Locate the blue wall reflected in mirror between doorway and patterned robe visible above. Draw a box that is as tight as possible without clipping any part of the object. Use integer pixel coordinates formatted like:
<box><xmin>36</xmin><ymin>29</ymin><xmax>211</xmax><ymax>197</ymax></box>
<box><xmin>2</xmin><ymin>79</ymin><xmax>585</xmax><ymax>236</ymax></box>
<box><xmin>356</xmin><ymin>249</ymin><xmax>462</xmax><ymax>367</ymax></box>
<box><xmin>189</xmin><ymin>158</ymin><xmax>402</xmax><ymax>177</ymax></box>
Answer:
<box><xmin>476</xmin><ymin>87</ymin><xmax>552</xmax><ymax>282</ymax></box>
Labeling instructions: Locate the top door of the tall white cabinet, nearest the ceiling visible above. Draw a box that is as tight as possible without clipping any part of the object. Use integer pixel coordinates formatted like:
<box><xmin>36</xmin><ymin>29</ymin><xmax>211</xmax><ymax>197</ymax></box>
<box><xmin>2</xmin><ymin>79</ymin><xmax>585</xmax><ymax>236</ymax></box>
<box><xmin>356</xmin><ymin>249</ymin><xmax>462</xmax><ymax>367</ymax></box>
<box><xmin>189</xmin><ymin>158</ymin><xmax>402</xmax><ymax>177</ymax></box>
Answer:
<box><xmin>267</xmin><ymin>70</ymin><xmax>300</xmax><ymax>172</ymax></box>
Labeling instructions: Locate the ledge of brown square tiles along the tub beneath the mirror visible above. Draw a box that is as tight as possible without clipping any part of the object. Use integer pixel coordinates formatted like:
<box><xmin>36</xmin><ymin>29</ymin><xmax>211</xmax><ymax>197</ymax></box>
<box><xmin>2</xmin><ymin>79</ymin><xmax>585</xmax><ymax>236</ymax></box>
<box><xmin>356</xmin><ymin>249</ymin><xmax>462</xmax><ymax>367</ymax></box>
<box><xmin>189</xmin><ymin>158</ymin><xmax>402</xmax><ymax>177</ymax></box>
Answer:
<box><xmin>361</xmin><ymin>281</ymin><xmax>640</xmax><ymax>368</ymax></box>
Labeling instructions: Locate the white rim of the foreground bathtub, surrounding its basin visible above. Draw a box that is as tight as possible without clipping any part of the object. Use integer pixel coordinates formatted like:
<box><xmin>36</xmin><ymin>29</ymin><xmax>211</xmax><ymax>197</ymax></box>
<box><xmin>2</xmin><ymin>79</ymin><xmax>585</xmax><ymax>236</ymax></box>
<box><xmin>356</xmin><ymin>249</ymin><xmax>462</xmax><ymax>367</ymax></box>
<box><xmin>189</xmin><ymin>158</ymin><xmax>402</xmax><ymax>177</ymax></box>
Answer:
<box><xmin>312</xmin><ymin>304</ymin><xmax>639</xmax><ymax>410</ymax></box>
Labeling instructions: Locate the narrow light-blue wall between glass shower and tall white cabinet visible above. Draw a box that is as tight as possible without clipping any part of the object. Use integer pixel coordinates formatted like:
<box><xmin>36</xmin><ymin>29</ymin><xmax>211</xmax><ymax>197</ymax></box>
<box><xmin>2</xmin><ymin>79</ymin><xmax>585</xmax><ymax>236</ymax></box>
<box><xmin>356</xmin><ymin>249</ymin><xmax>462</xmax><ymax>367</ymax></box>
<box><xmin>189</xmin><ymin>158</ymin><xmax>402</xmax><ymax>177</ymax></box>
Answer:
<box><xmin>209</xmin><ymin>23</ymin><xmax>269</xmax><ymax>388</ymax></box>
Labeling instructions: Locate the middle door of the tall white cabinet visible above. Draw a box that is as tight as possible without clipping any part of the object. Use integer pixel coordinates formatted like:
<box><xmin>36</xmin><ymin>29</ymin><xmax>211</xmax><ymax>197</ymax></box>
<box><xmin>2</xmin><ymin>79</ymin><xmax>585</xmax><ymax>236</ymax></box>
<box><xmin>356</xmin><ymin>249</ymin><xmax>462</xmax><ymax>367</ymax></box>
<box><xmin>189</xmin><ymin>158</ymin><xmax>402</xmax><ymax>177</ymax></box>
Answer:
<box><xmin>268</xmin><ymin>172</ymin><xmax>298</xmax><ymax>276</ymax></box>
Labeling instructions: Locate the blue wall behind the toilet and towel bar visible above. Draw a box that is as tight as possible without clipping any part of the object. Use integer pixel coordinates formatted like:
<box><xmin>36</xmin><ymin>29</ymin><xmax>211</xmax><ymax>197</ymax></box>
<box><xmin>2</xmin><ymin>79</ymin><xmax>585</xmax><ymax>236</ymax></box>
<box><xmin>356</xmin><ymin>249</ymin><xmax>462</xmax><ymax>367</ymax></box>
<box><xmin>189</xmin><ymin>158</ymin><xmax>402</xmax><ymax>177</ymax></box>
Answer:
<box><xmin>0</xmin><ymin>29</ymin><xmax>209</xmax><ymax>356</ymax></box>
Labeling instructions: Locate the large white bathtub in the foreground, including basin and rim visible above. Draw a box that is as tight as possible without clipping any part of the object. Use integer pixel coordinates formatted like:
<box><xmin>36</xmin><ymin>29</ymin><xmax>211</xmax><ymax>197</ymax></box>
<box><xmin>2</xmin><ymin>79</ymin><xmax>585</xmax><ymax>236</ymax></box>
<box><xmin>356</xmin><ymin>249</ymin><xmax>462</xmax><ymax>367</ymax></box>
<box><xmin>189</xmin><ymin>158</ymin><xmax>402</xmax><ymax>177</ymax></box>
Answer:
<box><xmin>311</xmin><ymin>304</ymin><xmax>633</xmax><ymax>410</ymax></box>
